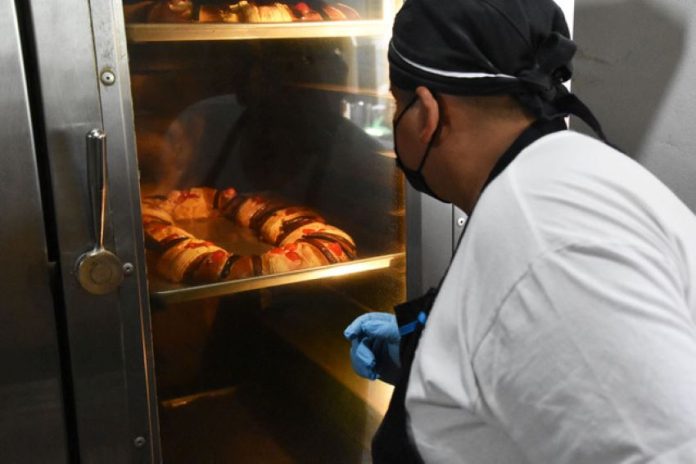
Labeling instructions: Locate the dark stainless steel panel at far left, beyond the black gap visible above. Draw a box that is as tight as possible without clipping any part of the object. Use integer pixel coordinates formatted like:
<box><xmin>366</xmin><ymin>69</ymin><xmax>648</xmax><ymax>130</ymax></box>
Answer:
<box><xmin>0</xmin><ymin>0</ymin><xmax>69</xmax><ymax>463</ymax></box>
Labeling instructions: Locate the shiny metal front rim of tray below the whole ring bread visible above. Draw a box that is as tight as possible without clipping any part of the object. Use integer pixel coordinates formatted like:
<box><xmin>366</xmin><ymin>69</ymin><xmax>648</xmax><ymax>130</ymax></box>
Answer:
<box><xmin>150</xmin><ymin>253</ymin><xmax>405</xmax><ymax>305</ymax></box>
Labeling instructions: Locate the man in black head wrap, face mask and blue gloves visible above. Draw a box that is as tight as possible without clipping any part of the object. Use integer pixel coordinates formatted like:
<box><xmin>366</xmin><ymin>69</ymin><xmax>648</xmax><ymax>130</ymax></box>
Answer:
<box><xmin>345</xmin><ymin>0</ymin><xmax>696</xmax><ymax>464</ymax></box>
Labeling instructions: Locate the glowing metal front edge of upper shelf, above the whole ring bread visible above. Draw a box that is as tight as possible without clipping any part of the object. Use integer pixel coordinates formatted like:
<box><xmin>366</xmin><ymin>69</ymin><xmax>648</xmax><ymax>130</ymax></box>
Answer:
<box><xmin>126</xmin><ymin>19</ymin><xmax>390</xmax><ymax>43</ymax></box>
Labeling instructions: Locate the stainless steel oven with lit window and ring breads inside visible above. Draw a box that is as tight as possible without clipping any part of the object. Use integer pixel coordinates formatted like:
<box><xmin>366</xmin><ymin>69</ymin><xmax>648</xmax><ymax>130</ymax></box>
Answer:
<box><xmin>0</xmin><ymin>0</ymin><xmax>474</xmax><ymax>463</ymax></box>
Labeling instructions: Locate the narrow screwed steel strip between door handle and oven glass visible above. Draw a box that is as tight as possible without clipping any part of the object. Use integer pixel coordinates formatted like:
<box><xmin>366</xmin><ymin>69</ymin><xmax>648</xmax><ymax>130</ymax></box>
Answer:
<box><xmin>91</xmin><ymin>0</ymin><xmax>161</xmax><ymax>462</ymax></box>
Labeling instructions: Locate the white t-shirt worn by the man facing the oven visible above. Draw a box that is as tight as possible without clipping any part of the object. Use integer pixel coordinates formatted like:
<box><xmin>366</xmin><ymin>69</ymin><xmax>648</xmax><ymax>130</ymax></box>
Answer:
<box><xmin>406</xmin><ymin>131</ymin><xmax>696</xmax><ymax>464</ymax></box>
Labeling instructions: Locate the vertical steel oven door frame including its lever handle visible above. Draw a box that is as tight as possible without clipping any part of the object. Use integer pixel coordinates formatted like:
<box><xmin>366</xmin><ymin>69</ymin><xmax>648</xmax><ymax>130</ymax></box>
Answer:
<box><xmin>21</xmin><ymin>0</ymin><xmax>160</xmax><ymax>463</ymax></box>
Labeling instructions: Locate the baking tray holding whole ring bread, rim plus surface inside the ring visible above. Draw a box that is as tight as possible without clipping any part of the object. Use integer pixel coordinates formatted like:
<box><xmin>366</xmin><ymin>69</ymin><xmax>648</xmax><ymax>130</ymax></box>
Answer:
<box><xmin>148</xmin><ymin>218</ymin><xmax>405</xmax><ymax>305</ymax></box>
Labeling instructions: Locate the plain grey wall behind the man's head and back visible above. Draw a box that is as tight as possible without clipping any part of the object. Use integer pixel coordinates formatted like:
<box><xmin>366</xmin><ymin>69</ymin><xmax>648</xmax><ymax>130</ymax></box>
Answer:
<box><xmin>571</xmin><ymin>0</ymin><xmax>696</xmax><ymax>211</ymax></box>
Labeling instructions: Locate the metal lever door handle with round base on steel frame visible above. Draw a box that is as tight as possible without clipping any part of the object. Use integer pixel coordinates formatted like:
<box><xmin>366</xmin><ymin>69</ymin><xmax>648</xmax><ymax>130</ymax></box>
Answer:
<box><xmin>76</xmin><ymin>129</ymin><xmax>123</xmax><ymax>295</ymax></box>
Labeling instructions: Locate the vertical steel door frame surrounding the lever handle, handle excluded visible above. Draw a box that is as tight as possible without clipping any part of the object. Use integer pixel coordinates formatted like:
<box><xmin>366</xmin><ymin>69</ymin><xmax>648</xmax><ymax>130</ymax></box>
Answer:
<box><xmin>30</xmin><ymin>0</ymin><xmax>159</xmax><ymax>463</ymax></box>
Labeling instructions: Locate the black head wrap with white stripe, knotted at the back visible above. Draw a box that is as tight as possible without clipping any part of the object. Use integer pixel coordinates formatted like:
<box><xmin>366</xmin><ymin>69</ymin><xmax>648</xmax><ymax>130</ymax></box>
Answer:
<box><xmin>389</xmin><ymin>0</ymin><xmax>605</xmax><ymax>139</ymax></box>
